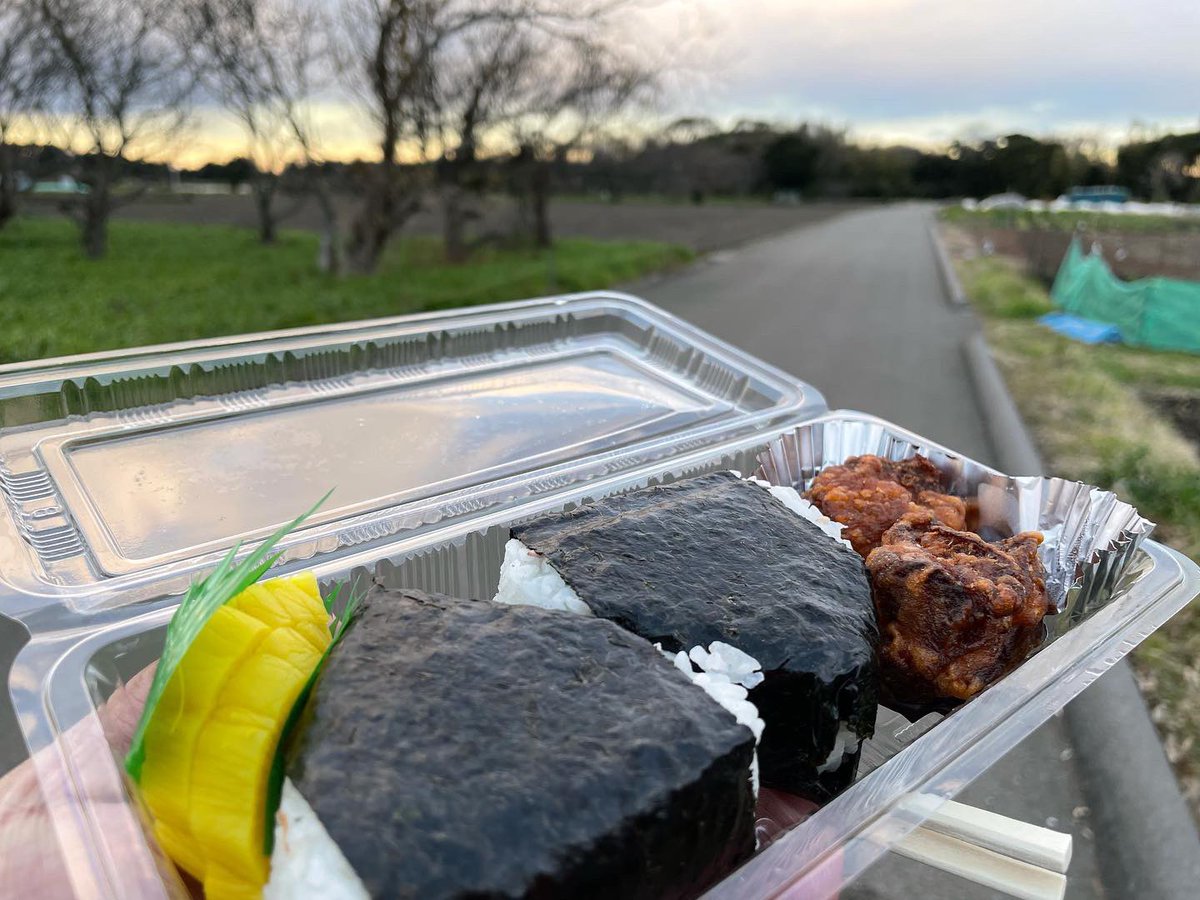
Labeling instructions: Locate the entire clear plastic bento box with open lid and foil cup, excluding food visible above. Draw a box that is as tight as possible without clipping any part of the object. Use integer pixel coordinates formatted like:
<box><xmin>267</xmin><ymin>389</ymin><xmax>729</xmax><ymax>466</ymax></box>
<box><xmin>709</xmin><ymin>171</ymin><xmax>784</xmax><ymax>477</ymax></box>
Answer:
<box><xmin>0</xmin><ymin>294</ymin><xmax>1200</xmax><ymax>898</ymax></box>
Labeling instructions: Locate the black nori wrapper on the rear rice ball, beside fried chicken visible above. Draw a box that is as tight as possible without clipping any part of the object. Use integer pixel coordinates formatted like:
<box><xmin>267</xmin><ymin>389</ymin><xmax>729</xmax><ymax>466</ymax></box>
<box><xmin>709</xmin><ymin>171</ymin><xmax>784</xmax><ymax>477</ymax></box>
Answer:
<box><xmin>511</xmin><ymin>472</ymin><xmax>878</xmax><ymax>800</ymax></box>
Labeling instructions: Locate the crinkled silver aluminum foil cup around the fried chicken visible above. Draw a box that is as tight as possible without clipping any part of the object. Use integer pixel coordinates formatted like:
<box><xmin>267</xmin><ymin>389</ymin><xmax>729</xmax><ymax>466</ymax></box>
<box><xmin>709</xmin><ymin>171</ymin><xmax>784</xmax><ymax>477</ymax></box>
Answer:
<box><xmin>757</xmin><ymin>416</ymin><xmax>1154</xmax><ymax>646</ymax></box>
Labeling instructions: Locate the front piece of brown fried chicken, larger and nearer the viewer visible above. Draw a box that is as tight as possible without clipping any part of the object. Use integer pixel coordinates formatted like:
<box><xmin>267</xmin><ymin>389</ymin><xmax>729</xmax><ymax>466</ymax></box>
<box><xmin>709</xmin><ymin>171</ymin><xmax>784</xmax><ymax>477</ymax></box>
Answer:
<box><xmin>866</xmin><ymin>509</ymin><xmax>1049</xmax><ymax>702</ymax></box>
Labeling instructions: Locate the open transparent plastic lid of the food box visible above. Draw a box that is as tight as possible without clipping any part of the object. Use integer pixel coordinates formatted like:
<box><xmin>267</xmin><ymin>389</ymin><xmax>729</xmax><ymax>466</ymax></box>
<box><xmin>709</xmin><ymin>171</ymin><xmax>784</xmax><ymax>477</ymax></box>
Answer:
<box><xmin>0</xmin><ymin>294</ymin><xmax>826</xmax><ymax>617</ymax></box>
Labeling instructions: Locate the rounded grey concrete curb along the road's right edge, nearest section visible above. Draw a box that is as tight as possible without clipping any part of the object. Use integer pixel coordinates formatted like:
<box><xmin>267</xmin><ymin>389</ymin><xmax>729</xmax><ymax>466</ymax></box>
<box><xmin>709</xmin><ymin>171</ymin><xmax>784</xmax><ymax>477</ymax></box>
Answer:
<box><xmin>964</xmin><ymin>332</ymin><xmax>1200</xmax><ymax>900</ymax></box>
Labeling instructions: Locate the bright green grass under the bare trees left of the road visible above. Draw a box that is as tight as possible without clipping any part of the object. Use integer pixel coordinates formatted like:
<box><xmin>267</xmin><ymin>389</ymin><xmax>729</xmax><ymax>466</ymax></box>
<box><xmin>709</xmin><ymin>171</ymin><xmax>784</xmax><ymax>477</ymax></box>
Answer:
<box><xmin>0</xmin><ymin>217</ymin><xmax>692</xmax><ymax>362</ymax></box>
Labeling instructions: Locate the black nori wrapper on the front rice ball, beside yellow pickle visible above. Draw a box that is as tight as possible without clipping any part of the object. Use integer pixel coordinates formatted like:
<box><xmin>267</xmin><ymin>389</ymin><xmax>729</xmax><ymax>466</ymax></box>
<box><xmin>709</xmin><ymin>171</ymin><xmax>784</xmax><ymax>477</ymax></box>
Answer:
<box><xmin>287</xmin><ymin>587</ymin><xmax>755</xmax><ymax>899</ymax></box>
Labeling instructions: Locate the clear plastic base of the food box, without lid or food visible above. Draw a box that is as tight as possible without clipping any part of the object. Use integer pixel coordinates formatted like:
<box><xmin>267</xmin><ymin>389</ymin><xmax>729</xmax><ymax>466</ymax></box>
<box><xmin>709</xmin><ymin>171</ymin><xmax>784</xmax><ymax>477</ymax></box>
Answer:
<box><xmin>11</xmin><ymin>413</ymin><xmax>1200</xmax><ymax>898</ymax></box>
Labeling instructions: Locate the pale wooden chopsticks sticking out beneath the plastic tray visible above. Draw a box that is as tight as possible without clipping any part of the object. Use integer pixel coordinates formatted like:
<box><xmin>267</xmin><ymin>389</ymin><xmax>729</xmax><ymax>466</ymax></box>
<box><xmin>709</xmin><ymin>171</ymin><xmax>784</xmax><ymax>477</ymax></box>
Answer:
<box><xmin>893</xmin><ymin>794</ymin><xmax>1072</xmax><ymax>900</ymax></box>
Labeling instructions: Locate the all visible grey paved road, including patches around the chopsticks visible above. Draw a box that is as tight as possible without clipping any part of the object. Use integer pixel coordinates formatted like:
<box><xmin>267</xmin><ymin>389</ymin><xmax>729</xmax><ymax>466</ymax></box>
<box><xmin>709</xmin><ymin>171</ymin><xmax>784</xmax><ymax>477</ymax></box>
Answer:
<box><xmin>630</xmin><ymin>205</ymin><xmax>1104</xmax><ymax>900</ymax></box>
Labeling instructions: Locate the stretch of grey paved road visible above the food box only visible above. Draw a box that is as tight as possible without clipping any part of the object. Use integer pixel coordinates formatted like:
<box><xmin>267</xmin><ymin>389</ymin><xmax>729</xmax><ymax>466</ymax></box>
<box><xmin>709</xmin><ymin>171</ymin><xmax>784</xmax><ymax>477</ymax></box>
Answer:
<box><xmin>631</xmin><ymin>205</ymin><xmax>991</xmax><ymax>460</ymax></box>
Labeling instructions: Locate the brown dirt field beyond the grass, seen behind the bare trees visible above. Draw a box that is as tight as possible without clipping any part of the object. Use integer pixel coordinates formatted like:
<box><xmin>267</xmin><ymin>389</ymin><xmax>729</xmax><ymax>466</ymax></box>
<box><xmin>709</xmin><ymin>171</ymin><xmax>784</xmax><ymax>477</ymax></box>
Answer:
<box><xmin>31</xmin><ymin>196</ymin><xmax>856</xmax><ymax>253</ymax></box>
